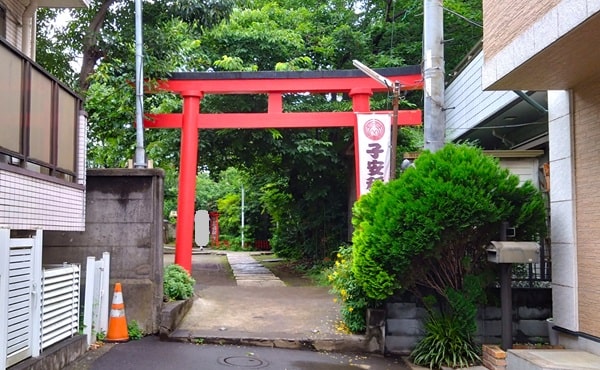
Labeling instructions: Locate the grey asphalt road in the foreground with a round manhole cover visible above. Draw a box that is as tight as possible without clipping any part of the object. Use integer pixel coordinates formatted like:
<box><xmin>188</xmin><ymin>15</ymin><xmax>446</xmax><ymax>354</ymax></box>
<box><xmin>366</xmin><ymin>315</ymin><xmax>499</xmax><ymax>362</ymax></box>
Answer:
<box><xmin>82</xmin><ymin>336</ymin><xmax>410</xmax><ymax>370</ymax></box>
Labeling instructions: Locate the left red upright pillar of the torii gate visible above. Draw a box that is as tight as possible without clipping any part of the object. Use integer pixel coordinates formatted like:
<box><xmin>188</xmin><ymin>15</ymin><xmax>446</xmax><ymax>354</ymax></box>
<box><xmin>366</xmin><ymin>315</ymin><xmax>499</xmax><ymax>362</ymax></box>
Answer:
<box><xmin>175</xmin><ymin>92</ymin><xmax>202</xmax><ymax>274</ymax></box>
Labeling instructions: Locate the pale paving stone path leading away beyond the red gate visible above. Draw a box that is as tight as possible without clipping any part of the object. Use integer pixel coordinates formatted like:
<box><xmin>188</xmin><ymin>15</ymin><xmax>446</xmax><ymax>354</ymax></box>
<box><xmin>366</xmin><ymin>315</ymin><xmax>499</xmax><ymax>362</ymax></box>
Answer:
<box><xmin>227</xmin><ymin>252</ymin><xmax>285</xmax><ymax>287</ymax></box>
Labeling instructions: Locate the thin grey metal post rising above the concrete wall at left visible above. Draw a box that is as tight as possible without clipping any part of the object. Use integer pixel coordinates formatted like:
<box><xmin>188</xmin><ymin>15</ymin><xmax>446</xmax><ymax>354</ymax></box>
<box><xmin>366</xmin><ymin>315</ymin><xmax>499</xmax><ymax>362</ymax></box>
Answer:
<box><xmin>133</xmin><ymin>0</ymin><xmax>147</xmax><ymax>168</ymax></box>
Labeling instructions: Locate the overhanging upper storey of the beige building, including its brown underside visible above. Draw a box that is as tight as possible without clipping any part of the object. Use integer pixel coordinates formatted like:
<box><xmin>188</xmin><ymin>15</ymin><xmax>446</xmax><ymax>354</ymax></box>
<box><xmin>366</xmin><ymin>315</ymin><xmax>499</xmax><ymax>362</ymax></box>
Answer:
<box><xmin>482</xmin><ymin>0</ymin><xmax>600</xmax><ymax>90</ymax></box>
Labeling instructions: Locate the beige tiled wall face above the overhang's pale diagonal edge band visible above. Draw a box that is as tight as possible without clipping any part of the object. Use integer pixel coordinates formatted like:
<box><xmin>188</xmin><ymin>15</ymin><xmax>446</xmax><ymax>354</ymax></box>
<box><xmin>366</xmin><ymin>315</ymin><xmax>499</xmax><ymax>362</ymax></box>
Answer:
<box><xmin>483</xmin><ymin>0</ymin><xmax>560</xmax><ymax>58</ymax></box>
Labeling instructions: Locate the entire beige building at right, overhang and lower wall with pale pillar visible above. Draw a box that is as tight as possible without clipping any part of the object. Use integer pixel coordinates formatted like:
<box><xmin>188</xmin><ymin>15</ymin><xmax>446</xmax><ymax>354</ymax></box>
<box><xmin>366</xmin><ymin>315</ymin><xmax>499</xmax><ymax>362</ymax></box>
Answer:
<box><xmin>482</xmin><ymin>0</ymin><xmax>600</xmax><ymax>355</ymax></box>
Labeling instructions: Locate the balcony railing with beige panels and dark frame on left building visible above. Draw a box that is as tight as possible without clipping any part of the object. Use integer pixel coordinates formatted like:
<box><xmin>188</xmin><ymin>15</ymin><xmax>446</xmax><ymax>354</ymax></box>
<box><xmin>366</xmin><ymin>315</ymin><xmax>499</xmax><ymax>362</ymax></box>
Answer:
<box><xmin>0</xmin><ymin>38</ymin><xmax>84</xmax><ymax>182</ymax></box>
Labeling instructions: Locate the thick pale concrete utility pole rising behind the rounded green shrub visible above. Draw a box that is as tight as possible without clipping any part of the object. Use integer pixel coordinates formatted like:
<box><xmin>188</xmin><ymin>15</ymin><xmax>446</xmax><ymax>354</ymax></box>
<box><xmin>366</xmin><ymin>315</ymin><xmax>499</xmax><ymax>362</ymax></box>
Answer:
<box><xmin>423</xmin><ymin>0</ymin><xmax>446</xmax><ymax>152</ymax></box>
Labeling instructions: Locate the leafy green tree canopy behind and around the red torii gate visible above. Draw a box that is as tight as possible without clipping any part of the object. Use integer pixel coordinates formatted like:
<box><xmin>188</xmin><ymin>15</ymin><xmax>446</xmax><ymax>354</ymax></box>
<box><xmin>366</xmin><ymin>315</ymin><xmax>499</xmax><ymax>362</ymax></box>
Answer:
<box><xmin>37</xmin><ymin>0</ymin><xmax>481</xmax><ymax>258</ymax></box>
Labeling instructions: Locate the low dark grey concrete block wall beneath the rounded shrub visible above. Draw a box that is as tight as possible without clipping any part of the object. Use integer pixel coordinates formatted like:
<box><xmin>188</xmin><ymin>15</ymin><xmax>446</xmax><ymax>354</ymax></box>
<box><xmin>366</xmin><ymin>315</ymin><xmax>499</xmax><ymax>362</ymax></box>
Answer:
<box><xmin>385</xmin><ymin>288</ymin><xmax>552</xmax><ymax>355</ymax></box>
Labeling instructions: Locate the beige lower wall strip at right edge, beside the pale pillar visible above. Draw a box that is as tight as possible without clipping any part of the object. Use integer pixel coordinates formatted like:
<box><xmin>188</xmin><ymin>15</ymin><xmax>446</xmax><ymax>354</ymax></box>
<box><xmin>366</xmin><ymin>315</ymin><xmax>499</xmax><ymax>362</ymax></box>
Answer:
<box><xmin>573</xmin><ymin>77</ymin><xmax>600</xmax><ymax>337</ymax></box>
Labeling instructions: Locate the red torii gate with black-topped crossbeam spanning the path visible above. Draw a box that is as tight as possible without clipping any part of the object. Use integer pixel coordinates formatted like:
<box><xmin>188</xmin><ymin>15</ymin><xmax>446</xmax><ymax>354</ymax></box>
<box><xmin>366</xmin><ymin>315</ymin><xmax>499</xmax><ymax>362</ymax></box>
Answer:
<box><xmin>144</xmin><ymin>66</ymin><xmax>423</xmax><ymax>273</ymax></box>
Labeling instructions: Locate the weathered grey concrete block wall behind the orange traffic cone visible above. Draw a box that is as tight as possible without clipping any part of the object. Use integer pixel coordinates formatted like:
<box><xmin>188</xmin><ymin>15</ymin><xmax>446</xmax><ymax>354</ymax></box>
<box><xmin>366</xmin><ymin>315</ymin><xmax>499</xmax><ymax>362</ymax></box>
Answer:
<box><xmin>42</xmin><ymin>169</ymin><xmax>164</xmax><ymax>333</ymax></box>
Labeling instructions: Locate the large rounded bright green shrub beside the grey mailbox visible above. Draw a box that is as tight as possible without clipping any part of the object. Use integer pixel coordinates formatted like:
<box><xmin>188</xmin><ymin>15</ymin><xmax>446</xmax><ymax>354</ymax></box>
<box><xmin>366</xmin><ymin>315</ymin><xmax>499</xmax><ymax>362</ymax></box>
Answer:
<box><xmin>352</xmin><ymin>145</ymin><xmax>545</xmax><ymax>300</ymax></box>
